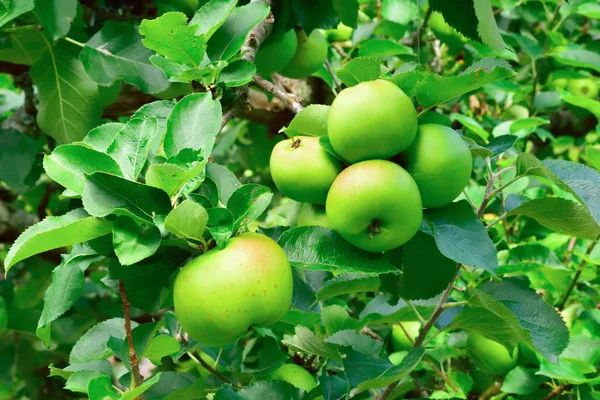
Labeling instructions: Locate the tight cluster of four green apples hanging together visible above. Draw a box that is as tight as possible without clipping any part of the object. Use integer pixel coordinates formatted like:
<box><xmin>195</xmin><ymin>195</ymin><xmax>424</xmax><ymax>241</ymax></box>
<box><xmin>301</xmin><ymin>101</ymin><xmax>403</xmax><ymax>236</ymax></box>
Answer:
<box><xmin>270</xmin><ymin>79</ymin><xmax>473</xmax><ymax>252</ymax></box>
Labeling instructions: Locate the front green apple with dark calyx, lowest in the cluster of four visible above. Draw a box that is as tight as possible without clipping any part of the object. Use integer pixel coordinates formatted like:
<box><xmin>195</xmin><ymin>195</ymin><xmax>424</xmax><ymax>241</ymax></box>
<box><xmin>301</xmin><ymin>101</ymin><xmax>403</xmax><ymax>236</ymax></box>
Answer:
<box><xmin>325</xmin><ymin>160</ymin><xmax>423</xmax><ymax>252</ymax></box>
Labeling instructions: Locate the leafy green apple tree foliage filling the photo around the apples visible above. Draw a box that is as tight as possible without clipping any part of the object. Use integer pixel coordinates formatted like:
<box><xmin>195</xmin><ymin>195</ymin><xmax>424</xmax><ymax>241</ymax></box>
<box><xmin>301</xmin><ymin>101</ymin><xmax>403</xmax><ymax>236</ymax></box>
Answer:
<box><xmin>0</xmin><ymin>0</ymin><xmax>600</xmax><ymax>400</ymax></box>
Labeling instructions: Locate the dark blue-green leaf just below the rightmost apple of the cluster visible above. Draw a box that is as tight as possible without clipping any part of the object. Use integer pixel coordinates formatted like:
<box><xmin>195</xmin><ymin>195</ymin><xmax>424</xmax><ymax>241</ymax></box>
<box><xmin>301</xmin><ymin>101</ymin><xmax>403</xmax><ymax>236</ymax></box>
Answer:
<box><xmin>425</xmin><ymin>200</ymin><xmax>498</xmax><ymax>273</ymax></box>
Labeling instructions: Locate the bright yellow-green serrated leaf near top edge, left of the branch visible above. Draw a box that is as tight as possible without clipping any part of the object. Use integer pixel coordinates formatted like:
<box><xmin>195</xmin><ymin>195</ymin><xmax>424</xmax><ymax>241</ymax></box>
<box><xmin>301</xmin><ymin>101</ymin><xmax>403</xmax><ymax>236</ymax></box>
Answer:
<box><xmin>140</xmin><ymin>12</ymin><xmax>206</xmax><ymax>67</ymax></box>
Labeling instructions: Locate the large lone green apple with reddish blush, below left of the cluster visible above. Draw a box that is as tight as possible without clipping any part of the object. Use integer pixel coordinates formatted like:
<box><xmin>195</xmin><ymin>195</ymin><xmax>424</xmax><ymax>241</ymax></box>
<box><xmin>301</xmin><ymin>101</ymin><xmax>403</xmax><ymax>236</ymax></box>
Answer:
<box><xmin>173</xmin><ymin>233</ymin><xmax>292</xmax><ymax>346</ymax></box>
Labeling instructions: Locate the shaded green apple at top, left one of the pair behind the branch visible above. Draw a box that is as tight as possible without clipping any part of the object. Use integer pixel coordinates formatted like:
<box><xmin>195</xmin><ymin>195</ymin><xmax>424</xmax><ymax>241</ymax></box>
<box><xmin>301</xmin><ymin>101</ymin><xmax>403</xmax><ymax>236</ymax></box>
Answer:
<box><xmin>255</xmin><ymin>29</ymin><xmax>298</xmax><ymax>77</ymax></box>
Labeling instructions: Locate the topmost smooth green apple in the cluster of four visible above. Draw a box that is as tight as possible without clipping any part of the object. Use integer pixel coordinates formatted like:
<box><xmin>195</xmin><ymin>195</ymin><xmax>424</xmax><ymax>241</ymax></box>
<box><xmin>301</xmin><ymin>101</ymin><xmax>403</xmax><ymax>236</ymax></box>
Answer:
<box><xmin>328</xmin><ymin>79</ymin><xmax>417</xmax><ymax>163</ymax></box>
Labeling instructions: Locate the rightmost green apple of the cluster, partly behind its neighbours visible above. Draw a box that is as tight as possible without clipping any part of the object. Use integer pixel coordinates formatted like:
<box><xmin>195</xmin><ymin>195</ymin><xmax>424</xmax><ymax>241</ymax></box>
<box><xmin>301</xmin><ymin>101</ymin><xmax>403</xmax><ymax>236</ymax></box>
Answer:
<box><xmin>400</xmin><ymin>124</ymin><xmax>473</xmax><ymax>208</ymax></box>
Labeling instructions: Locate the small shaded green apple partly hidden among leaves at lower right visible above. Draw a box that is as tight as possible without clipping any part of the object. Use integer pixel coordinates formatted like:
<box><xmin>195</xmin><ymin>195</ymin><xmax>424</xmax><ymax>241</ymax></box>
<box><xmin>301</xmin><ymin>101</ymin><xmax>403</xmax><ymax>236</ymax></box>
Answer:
<box><xmin>467</xmin><ymin>332</ymin><xmax>518</xmax><ymax>375</ymax></box>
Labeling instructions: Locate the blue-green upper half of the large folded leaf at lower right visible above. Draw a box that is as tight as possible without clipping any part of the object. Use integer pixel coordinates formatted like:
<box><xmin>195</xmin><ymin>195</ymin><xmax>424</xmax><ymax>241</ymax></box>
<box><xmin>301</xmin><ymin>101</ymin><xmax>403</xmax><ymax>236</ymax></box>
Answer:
<box><xmin>481</xmin><ymin>279</ymin><xmax>569</xmax><ymax>362</ymax></box>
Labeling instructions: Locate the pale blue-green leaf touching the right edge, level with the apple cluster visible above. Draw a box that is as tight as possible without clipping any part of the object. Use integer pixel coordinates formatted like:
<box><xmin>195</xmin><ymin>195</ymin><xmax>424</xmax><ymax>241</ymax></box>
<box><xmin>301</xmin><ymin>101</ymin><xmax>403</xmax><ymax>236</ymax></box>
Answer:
<box><xmin>517</xmin><ymin>153</ymin><xmax>600</xmax><ymax>228</ymax></box>
